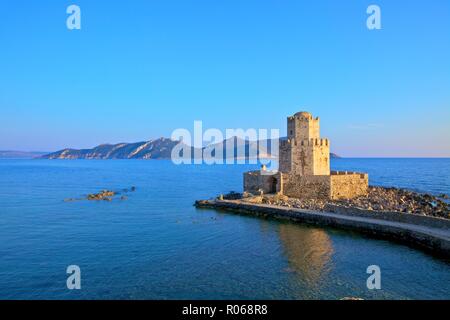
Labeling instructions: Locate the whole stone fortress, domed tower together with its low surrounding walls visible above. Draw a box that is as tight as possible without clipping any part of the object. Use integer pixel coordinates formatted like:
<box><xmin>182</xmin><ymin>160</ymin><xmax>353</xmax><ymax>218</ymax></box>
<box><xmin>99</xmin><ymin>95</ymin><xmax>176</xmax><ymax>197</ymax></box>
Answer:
<box><xmin>244</xmin><ymin>112</ymin><xmax>369</xmax><ymax>199</ymax></box>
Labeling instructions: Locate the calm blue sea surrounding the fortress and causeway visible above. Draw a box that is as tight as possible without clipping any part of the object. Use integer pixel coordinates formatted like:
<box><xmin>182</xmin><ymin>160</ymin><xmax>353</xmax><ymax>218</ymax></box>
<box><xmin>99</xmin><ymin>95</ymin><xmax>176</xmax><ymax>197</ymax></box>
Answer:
<box><xmin>0</xmin><ymin>159</ymin><xmax>450</xmax><ymax>299</ymax></box>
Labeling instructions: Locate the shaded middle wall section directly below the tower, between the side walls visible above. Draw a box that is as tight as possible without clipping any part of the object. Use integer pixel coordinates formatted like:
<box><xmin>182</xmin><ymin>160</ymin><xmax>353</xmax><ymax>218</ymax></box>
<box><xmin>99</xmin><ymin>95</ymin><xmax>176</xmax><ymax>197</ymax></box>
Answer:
<box><xmin>282</xmin><ymin>174</ymin><xmax>330</xmax><ymax>199</ymax></box>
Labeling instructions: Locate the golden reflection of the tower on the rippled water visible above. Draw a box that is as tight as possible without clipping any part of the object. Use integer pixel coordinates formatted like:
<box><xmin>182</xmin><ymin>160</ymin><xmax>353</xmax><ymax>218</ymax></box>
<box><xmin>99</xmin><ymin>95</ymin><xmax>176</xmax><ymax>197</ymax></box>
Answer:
<box><xmin>279</xmin><ymin>223</ymin><xmax>333</xmax><ymax>285</ymax></box>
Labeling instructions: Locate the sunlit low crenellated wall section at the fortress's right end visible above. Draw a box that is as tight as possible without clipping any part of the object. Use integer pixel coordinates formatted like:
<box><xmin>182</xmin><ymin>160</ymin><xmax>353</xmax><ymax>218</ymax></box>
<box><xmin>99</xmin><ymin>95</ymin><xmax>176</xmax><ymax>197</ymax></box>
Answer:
<box><xmin>330</xmin><ymin>171</ymin><xmax>369</xmax><ymax>199</ymax></box>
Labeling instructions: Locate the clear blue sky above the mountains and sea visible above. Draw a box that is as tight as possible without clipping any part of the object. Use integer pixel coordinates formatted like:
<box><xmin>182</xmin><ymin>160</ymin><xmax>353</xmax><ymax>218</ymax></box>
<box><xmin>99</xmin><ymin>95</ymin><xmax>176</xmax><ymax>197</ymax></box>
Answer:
<box><xmin>0</xmin><ymin>0</ymin><xmax>450</xmax><ymax>157</ymax></box>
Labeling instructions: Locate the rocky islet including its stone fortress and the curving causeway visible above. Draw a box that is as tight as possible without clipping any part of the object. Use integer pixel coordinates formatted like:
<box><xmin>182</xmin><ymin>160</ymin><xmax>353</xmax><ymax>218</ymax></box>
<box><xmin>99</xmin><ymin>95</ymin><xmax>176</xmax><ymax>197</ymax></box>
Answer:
<box><xmin>195</xmin><ymin>111</ymin><xmax>450</xmax><ymax>256</ymax></box>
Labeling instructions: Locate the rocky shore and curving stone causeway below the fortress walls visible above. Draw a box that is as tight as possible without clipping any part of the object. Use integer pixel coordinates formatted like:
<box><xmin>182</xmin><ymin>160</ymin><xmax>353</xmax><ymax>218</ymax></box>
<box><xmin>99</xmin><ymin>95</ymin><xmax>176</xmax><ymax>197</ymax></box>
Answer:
<box><xmin>195</xmin><ymin>187</ymin><xmax>450</xmax><ymax>257</ymax></box>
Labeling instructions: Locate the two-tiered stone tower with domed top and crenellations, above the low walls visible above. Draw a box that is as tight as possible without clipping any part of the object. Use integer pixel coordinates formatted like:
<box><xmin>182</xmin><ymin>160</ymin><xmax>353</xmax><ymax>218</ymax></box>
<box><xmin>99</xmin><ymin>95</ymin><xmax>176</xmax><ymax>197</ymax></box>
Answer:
<box><xmin>279</xmin><ymin>112</ymin><xmax>330</xmax><ymax>176</ymax></box>
